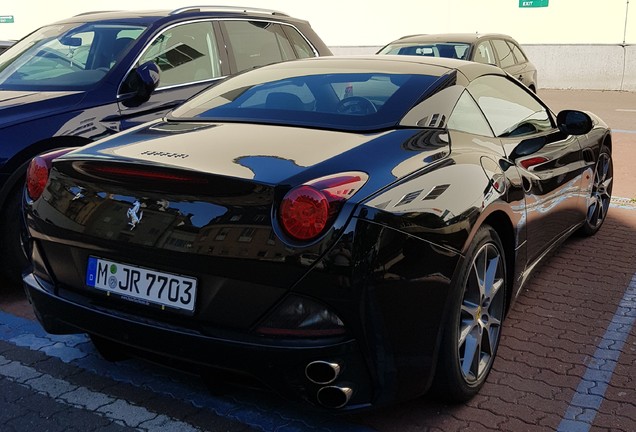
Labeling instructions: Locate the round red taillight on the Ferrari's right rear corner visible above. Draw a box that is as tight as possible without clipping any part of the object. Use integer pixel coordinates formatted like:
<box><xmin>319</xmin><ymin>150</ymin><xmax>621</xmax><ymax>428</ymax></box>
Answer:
<box><xmin>278</xmin><ymin>172</ymin><xmax>369</xmax><ymax>241</ymax></box>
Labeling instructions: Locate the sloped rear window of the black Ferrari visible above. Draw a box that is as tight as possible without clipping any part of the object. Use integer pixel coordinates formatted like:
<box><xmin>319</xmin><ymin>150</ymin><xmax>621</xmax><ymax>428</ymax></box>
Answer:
<box><xmin>173</xmin><ymin>67</ymin><xmax>438</xmax><ymax>130</ymax></box>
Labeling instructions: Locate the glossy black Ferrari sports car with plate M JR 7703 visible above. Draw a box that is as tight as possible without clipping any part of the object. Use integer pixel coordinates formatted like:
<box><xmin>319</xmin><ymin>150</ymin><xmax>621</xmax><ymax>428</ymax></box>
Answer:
<box><xmin>24</xmin><ymin>56</ymin><xmax>612</xmax><ymax>410</ymax></box>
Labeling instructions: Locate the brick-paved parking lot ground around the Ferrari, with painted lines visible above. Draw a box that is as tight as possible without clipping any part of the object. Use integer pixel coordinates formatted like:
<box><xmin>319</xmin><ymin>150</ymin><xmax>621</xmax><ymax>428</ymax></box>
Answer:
<box><xmin>0</xmin><ymin>90</ymin><xmax>636</xmax><ymax>432</ymax></box>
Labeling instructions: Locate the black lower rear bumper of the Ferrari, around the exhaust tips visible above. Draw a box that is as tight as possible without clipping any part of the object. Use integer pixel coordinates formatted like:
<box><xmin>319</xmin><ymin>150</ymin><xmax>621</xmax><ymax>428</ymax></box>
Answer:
<box><xmin>23</xmin><ymin>274</ymin><xmax>373</xmax><ymax>410</ymax></box>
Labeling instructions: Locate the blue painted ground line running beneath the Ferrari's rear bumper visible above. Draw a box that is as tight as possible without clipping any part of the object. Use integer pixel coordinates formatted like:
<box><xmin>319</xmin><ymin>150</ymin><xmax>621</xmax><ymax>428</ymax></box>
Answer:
<box><xmin>0</xmin><ymin>311</ymin><xmax>373</xmax><ymax>432</ymax></box>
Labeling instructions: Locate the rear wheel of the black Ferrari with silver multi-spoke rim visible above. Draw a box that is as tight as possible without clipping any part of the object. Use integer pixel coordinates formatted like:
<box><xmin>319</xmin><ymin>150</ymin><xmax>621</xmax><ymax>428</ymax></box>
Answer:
<box><xmin>433</xmin><ymin>225</ymin><xmax>508</xmax><ymax>402</ymax></box>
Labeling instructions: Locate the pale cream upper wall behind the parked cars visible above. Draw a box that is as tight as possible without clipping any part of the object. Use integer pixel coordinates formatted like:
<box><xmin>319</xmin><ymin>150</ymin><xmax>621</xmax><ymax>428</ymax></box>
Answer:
<box><xmin>0</xmin><ymin>0</ymin><xmax>636</xmax><ymax>46</ymax></box>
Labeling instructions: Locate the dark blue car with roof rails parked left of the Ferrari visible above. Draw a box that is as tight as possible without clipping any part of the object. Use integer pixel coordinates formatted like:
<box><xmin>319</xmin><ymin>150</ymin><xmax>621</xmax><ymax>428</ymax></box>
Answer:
<box><xmin>0</xmin><ymin>7</ymin><xmax>331</xmax><ymax>280</ymax></box>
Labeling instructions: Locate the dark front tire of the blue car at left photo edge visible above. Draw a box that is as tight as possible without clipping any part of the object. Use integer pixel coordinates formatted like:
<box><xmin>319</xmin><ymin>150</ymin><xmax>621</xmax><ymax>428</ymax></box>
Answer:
<box><xmin>0</xmin><ymin>180</ymin><xmax>29</xmax><ymax>284</ymax></box>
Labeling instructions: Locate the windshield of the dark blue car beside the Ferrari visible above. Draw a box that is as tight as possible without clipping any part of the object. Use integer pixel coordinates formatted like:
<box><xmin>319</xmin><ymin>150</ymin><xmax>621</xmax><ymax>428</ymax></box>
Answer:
<box><xmin>0</xmin><ymin>23</ymin><xmax>145</xmax><ymax>91</ymax></box>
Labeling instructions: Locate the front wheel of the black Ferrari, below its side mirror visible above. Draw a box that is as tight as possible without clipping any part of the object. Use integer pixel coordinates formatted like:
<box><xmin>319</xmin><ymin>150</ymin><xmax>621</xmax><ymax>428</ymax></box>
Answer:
<box><xmin>578</xmin><ymin>145</ymin><xmax>614</xmax><ymax>236</ymax></box>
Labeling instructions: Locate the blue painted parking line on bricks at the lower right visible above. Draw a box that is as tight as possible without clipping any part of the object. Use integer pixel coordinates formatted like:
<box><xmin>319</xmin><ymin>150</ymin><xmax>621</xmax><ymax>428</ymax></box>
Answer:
<box><xmin>557</xmin><ymin>274</ymin><xmax>636</xmax><ymax>432</ymax></box>
